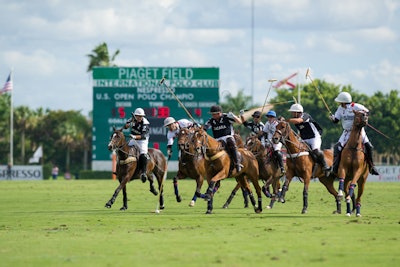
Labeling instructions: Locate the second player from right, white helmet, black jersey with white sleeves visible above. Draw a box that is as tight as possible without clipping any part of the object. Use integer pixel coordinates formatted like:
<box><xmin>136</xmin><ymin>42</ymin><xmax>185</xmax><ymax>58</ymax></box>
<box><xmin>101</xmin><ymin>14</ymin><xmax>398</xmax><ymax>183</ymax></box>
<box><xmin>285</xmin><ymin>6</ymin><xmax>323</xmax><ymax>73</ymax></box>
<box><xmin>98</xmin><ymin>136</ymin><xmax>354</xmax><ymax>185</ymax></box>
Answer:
<box><xmin>287</xmin><ymin>104</ymin><xmax>330</xmax><ymax>176</ymax></box>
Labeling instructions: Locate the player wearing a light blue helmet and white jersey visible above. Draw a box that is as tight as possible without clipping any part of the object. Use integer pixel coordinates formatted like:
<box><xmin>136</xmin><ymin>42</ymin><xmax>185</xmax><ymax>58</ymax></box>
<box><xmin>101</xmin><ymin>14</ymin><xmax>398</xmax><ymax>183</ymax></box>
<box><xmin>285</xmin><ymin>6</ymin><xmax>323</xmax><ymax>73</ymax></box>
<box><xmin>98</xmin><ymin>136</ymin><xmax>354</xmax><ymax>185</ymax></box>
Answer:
<box><xmin>263</xmin><ymin>110</ymin><xmax>286</xmax><ymax>175</ymax></box>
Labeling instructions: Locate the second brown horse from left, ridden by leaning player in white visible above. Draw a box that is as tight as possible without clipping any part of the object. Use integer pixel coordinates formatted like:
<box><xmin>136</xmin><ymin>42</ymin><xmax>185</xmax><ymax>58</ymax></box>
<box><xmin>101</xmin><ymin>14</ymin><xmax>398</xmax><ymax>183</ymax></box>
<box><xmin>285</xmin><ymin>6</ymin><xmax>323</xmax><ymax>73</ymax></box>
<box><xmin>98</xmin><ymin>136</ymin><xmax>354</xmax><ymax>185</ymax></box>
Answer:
<box><xmin>173</xmin><ymin>128</ymin><xmax>206</xmax><ymax>207</ymax></box>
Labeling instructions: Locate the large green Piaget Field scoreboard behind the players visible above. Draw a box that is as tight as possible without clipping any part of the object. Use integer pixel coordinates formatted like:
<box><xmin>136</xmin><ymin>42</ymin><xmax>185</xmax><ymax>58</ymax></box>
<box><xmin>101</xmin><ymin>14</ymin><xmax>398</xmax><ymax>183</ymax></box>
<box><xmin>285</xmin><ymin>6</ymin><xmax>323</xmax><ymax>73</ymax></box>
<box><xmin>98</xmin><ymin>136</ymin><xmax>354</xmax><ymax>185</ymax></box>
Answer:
<box><xmin>92</xmin><ymin>67</ymin><xmax>219</xmax><ymax>170</ymax></box>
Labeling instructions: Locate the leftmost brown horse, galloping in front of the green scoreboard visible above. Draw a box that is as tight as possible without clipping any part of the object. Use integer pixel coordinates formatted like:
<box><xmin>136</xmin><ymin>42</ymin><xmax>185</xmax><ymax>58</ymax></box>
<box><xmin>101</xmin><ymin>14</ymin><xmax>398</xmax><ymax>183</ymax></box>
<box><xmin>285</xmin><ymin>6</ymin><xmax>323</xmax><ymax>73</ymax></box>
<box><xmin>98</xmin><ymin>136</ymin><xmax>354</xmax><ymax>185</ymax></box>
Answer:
<box><xmin>105</xmin><ymin>128</ymin><xmax>167</xmax><ymax>210</ymax></box>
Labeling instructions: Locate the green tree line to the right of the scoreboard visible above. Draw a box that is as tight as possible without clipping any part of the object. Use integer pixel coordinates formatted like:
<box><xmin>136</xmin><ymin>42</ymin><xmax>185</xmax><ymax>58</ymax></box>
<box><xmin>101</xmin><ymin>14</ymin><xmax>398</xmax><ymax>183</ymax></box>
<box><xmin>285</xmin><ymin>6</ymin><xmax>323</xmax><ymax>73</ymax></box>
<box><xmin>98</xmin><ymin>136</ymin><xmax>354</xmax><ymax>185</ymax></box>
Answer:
<box><xmin>221</xmin><ymin>79</ymin><xmax>400</xmax><ymax>165</ymax></box>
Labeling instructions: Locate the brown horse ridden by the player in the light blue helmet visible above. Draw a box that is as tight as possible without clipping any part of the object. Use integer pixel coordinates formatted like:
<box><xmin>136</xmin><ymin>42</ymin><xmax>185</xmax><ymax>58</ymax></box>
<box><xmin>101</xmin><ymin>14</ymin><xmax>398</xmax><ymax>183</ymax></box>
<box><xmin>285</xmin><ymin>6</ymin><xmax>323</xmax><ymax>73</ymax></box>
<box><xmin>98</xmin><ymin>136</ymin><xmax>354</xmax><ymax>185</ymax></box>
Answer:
<box><xmin>223</xmin><ymin>135</ymin><xmax>281</xmax><ymax>209</ymax></box>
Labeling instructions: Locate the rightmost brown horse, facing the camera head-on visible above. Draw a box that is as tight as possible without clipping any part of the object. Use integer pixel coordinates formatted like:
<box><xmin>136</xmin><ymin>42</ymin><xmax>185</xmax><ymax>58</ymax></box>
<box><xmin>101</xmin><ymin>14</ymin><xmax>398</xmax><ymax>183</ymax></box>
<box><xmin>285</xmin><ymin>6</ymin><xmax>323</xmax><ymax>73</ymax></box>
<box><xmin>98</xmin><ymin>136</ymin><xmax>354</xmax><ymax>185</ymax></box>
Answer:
<box><xmin>338</xmin><ymin>111</ymin><xmax>369</xmax><ymax>217</ymax></box>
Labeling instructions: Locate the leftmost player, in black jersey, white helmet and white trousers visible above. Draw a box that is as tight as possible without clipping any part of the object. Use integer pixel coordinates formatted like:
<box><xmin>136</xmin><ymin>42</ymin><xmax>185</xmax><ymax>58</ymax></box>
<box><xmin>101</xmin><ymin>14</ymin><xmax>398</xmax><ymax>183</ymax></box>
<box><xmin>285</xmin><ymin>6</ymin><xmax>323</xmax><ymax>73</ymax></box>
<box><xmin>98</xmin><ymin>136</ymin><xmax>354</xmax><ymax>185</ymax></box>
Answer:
<box><xmin>124</xmin><ymin>108</ymin><xmax>150</xmax><ymax>183</ymax></box>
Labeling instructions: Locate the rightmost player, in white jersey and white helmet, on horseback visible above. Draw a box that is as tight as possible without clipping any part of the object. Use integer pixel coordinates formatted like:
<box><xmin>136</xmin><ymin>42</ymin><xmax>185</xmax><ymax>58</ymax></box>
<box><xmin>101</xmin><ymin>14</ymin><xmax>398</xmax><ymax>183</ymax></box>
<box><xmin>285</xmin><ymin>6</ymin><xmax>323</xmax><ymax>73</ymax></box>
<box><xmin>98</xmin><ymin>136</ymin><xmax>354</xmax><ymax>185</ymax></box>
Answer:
<box><xmin>331</xmin><ymin>92</ymin><xmax>379</xmax><ymax>175</ymax></box>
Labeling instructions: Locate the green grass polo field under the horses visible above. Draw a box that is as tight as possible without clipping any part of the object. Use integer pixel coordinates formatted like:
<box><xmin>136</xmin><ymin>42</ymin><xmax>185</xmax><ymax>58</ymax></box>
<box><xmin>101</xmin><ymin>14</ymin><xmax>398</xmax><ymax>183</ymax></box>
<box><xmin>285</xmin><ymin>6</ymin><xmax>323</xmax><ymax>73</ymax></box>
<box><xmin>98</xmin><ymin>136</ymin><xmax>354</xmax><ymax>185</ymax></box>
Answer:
<box><xmin>0</xmin><ymin>179</ymin><xmax>400</xmax><ymax>267</ymax></box>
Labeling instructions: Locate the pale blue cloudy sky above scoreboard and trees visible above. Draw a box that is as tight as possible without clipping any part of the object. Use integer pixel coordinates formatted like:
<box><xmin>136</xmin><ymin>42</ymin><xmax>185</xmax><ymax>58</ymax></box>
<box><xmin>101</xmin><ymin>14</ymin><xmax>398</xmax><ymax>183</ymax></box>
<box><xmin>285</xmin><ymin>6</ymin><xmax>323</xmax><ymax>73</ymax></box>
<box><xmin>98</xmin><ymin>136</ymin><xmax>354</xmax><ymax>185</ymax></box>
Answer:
<box><xmin>0</xmin><ymin>0</ymin><xmax>400</xmax><ymax>115</ymax></box>
